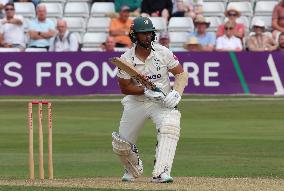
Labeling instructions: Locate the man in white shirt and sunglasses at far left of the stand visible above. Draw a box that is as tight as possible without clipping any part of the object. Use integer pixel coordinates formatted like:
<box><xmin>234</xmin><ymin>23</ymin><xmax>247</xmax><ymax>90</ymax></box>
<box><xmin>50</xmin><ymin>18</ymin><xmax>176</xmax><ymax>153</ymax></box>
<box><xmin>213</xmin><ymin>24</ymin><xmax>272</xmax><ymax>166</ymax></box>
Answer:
<box><xmin>0</xmin><ymin>3</ymin><xmax>26</xmax><ymax>50</ymax></box>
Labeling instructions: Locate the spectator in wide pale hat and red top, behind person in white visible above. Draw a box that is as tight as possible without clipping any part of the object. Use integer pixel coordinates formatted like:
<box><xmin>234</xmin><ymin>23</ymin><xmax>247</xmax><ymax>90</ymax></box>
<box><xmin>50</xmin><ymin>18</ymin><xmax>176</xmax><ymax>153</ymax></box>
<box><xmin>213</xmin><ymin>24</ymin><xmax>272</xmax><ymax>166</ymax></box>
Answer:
<box><xmin>216</xmin><ymin>7</ymin><xmax>245</xmax><ymax>39</ymax></box>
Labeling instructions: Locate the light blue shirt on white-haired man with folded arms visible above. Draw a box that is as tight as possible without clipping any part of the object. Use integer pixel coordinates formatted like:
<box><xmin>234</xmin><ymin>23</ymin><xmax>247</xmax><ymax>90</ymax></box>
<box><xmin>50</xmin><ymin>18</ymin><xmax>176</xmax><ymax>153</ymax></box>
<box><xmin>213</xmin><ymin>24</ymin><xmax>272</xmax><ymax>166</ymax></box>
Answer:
<box><xmin>29</xmin><ymin>19</ymin><xmax>55</xmax><ymax>47</ymax></box>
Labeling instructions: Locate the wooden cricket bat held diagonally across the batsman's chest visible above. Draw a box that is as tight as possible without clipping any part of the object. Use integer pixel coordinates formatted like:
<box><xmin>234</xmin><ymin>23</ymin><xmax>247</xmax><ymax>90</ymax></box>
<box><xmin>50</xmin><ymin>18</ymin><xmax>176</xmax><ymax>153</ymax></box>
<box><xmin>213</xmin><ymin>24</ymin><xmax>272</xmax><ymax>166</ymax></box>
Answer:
<box><xmin>109</xmin><ymin>57</ymin><xmax>165</xmax><ymax>95</ymax></box>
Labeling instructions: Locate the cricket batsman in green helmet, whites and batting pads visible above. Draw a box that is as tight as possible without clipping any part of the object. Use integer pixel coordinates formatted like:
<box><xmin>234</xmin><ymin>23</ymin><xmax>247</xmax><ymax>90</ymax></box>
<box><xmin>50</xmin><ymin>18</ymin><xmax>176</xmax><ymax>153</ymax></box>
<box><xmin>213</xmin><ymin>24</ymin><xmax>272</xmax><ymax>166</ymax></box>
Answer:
<box><xmin>112</xmin><ymin>17</ymin><xmax>188</xmax><ymax>183</ymax></box>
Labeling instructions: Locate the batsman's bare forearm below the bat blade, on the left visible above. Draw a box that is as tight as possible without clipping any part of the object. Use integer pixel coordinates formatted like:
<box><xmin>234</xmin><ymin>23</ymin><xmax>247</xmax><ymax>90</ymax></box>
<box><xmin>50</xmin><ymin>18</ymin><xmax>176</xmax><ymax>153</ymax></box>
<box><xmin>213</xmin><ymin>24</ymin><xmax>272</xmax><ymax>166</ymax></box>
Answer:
<box><xmin>118</xmin><ymin>77</ymin><xmax>144</xmax><ymax>95</ymax></box>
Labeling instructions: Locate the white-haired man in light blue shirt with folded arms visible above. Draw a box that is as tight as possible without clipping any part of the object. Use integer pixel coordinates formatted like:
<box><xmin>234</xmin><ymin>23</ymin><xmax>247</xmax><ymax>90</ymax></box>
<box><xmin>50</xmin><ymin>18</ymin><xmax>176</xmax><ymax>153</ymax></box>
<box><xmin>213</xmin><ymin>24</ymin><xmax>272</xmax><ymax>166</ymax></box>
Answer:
<box><xmin>28</xmin><ymin>4</ymin><xmax>55</xmax><ymax>50</ymax></box>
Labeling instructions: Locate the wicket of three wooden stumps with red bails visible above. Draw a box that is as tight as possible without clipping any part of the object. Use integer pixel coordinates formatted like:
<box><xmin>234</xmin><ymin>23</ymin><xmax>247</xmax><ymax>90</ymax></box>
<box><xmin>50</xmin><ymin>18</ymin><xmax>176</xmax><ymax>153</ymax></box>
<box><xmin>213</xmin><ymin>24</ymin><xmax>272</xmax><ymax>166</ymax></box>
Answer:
<box><xmin>28</xmin><ymin>101</ymin><xmax>53</xmax><ymax>180</ymax></box>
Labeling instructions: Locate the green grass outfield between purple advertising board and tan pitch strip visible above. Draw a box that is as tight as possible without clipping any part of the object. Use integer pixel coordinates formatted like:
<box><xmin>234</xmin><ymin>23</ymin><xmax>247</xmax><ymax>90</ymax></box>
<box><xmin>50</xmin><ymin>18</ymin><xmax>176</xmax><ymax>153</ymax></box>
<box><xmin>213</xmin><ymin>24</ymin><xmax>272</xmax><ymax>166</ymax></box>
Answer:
<box><xmin>0</xmin><ymin>96</ymin><xmax>284</xmax><ymax>190</ymax></box>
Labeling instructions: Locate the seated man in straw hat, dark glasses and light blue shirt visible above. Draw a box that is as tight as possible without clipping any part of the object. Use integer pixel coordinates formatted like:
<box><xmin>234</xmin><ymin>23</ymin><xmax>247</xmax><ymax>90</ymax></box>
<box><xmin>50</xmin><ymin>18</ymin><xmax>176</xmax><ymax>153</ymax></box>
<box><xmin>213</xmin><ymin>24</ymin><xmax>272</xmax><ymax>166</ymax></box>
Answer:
<box><xmin>189</xmin><ymin>15</ymin><xmax>216</xmax><ymax>51</ymax></box>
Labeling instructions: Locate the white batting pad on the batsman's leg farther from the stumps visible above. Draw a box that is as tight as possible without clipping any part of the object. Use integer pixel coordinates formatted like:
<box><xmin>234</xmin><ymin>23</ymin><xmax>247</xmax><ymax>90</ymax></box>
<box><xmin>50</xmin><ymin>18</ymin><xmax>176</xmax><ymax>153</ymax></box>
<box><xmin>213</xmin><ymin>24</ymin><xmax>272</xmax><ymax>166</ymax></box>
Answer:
<box><xmin>153</xmin><ymin>110</ymin><xmax>180</xmax><ymax>177</ymax></box>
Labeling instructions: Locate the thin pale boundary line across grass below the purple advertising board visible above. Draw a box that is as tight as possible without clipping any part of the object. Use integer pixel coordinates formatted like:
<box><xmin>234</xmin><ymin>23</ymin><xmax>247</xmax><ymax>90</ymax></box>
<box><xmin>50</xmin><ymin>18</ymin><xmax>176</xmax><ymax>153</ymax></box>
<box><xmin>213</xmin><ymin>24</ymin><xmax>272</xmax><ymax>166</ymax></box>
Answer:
<box><xmin>0</xmin><ymin>97</ymin><xmax>284</xmax><ymax>103</ymax></box>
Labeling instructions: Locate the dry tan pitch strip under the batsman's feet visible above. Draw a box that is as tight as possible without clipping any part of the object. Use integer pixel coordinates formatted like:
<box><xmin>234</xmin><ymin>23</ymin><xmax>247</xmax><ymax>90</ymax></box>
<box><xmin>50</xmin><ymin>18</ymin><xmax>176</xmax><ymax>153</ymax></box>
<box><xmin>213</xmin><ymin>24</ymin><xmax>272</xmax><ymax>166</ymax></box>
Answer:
<box><xmin>0</xmin><ymin>177</ymin><xmax>284</xmax><ymax>191</ymax></box>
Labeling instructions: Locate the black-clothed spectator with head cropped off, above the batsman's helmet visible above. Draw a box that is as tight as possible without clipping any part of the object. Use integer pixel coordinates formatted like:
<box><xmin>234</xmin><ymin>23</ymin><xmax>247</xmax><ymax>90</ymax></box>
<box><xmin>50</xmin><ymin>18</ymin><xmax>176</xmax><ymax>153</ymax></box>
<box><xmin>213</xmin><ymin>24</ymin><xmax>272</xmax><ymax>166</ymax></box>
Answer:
<box><xmin>141</xmin><ymin>0</ymin><xmax>173</xmax><ymax>20</ymax></box>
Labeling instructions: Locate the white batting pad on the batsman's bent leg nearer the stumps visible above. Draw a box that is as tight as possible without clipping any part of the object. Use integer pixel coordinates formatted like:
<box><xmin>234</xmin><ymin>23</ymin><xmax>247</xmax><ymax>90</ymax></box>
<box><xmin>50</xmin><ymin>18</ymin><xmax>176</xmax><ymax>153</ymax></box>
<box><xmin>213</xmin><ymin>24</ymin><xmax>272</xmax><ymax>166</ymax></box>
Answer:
<box><xmin>112</xmin><ymin>132</ymin><xmax>143</xmax><ymax>178</ymax></box>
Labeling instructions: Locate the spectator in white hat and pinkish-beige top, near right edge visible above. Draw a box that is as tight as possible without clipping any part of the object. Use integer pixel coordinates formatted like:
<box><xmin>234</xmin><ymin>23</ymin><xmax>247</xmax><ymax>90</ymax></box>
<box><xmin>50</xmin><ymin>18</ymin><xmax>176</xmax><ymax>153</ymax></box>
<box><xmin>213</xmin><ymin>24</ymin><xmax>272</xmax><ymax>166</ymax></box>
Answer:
<box><xmin>247</xmin><ymin>19</ymin><xmax>278</xmax><ymax>51</ymax></box>
